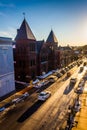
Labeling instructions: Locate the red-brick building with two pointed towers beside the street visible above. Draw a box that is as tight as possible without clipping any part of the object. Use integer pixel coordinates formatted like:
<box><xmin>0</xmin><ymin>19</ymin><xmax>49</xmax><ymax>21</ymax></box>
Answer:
<box><xmin>14</xmin><ymin>19</ymin><xmax>60</xmax><ymax>82</ymax></box>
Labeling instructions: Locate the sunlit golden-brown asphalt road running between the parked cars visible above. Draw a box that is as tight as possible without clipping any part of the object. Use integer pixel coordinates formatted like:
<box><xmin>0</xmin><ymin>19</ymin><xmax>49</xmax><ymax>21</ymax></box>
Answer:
<box><xmin>0</xmin><ymin>67</ymin><xmax>85</xmax><ymax>130</ymax></box>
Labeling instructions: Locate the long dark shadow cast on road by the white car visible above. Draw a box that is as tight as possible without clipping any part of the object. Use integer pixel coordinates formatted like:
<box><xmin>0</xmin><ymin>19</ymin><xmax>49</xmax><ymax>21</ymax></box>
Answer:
<box><xmin>17</xmin><ymin>101</ymin><xmax>44</xmax><ymax>123</ymax></box>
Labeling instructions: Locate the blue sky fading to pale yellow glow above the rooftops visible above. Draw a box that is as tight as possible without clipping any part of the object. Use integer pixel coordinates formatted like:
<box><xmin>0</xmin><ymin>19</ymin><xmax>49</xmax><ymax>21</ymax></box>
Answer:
<box><xmin>0</xmin><ymin>0</ymin><xmax>87</xmax><ymax>46</ymax></box>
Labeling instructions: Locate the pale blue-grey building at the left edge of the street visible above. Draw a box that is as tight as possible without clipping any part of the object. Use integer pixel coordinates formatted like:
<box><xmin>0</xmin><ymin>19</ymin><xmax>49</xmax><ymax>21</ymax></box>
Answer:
<box><xmin>0</xmin><ymin>37</ymin><xmax>15</xmax><ymax>98</ymax></box>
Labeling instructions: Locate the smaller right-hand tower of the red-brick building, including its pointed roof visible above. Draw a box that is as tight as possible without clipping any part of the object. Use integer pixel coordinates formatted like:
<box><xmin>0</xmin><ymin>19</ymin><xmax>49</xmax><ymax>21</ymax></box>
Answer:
<box><xmin>46</xmin><ymin>30</ymin><xmax>60</xmax><ymax>71</ymax></box>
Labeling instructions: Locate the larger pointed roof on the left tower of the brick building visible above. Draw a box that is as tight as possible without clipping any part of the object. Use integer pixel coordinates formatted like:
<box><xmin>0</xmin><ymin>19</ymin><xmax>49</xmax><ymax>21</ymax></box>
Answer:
<box><xmin>15</xmin><ymin>19</ymin><xmax>36</xmax><ymax>41</ymax></box>
